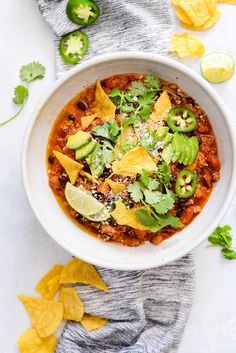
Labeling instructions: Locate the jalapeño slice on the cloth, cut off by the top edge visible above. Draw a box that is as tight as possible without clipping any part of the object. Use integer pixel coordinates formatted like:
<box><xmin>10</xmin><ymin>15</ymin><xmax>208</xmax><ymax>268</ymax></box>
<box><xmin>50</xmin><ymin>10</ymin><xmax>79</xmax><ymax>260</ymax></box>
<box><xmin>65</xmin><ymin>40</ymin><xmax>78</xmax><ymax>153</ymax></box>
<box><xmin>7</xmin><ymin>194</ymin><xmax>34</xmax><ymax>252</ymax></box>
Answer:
<box><xmin>66</xmin><ymin>0</ymin><xmax>100</xmax><ymax>26</ymax></box>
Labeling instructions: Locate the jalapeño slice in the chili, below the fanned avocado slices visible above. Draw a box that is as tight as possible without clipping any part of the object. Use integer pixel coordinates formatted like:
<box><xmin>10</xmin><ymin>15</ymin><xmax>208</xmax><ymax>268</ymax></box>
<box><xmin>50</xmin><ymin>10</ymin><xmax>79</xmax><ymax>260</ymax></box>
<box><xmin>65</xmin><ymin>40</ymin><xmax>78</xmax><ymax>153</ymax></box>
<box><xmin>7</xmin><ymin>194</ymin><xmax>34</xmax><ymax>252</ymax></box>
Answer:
<box><xmin>175</xmin><ymin>169</ymin><xmax>198</xmax><ymax>199</ymax></box>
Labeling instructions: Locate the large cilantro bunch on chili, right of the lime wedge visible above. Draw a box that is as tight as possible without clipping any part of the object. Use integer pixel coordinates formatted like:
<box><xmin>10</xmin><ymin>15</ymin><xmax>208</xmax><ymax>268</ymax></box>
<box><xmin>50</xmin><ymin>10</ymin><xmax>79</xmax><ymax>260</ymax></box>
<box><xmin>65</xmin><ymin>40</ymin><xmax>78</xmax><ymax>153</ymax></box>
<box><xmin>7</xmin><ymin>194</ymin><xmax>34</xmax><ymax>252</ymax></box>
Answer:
<box><xmin>127</xmin><ymin>163</ymin><xmax>183</xmax><ymax>232</ymax></box>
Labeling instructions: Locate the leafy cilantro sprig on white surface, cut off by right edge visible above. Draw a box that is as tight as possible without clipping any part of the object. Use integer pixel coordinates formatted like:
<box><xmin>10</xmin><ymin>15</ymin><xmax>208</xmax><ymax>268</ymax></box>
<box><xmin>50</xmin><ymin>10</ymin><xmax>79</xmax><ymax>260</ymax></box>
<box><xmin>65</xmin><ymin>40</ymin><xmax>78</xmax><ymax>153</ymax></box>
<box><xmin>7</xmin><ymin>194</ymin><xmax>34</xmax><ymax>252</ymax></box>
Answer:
<box><xmin>208</xmin><ymin>225</ymin><xmax>236</xmax><ymax>260</ymax></box>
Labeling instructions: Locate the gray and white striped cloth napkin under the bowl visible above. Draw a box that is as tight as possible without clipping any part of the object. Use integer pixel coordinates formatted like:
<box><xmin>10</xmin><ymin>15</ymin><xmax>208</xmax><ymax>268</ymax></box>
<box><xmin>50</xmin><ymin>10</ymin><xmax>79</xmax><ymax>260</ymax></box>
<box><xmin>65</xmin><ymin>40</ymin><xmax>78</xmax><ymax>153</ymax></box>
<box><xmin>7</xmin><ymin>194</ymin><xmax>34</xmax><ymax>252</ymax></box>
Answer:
<box><xmin>37</xmin><ymin>0</ymin><xmax>194</xmax><ymax>353</ymax></box>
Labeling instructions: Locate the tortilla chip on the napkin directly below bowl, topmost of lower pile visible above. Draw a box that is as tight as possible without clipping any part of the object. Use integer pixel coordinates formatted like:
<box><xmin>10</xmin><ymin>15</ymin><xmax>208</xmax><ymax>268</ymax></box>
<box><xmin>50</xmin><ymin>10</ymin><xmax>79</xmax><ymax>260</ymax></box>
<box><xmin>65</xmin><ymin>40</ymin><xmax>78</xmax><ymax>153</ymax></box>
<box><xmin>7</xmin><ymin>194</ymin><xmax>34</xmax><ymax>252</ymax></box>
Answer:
<box><xmin>60</xmin><ymin>258</ymin><xmax>108</xmax><ymax>292</ymax></box>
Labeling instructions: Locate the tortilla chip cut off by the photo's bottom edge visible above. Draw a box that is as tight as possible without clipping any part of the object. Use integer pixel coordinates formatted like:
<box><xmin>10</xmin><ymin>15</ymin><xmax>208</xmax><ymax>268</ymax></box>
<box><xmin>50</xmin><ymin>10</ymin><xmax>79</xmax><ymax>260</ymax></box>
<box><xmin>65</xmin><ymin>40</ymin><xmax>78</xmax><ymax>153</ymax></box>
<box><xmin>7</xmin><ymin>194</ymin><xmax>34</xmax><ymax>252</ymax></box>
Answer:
<box><xmin>18</xmin><ymin>327</ymin><xmax>57</xmax><ymax>353</ymax></box>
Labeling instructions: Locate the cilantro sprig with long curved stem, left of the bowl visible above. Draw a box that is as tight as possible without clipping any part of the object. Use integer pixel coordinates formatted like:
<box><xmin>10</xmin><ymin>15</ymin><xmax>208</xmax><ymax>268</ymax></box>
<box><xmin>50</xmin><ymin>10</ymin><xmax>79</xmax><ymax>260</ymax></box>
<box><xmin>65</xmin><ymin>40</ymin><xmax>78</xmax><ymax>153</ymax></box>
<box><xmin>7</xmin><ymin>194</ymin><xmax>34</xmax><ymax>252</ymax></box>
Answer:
<box><xmin>0</xmin><ymin>62</ymin><xmax>46</xmax><ymax>126</ymax></box>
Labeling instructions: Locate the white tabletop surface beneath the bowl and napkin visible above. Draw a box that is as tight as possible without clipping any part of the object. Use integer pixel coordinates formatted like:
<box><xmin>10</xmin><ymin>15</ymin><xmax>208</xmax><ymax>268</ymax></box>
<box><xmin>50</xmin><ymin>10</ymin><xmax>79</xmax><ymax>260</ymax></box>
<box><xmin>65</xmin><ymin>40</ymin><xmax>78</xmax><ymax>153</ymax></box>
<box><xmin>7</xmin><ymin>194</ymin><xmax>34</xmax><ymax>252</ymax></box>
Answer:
<box><xmin>0</xmin><ymin>0</ymin><xmax>236</xmax><ymax>353</ymax></box>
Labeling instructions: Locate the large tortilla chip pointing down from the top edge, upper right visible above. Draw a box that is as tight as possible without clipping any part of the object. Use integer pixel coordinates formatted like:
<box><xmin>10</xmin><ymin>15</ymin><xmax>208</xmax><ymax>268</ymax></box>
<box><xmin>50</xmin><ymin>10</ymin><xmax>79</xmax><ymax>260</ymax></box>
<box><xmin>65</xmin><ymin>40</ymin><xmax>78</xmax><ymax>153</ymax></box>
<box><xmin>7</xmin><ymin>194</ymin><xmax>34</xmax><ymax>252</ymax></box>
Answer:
<box><xmin>178</xmin><ymin>0</ymin><xmax>217</xmax><ymax>27</ymax></box>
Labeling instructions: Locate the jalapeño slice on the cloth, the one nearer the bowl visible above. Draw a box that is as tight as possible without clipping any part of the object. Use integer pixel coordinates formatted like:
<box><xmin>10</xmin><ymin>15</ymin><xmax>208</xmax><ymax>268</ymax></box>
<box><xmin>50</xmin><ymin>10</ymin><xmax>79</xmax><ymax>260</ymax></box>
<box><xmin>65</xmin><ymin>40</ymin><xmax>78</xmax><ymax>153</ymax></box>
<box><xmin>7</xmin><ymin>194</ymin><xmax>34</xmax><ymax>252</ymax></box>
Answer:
<box><xmin>59</xmin><ymin>29</ymin><xmax>89</xmax><ymax>64</ymax></box>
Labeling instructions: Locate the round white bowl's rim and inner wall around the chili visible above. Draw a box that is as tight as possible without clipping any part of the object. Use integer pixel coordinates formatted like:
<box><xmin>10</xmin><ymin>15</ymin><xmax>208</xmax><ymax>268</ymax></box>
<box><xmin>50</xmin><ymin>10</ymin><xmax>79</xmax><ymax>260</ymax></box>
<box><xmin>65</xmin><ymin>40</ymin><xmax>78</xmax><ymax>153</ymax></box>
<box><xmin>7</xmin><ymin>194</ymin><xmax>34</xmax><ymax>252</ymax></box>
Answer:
<box><xmin>22</xmin><ymin>52</ymin><xmax>236</xmax><ymax>270</ymax></box>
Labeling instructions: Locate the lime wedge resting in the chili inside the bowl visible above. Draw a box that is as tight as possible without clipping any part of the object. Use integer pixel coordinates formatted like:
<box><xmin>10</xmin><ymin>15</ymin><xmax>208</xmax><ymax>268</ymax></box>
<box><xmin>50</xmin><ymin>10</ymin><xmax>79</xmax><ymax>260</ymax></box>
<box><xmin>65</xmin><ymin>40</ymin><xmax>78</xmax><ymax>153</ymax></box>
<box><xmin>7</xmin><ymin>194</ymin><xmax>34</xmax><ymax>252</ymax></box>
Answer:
<box><xmin>65</xmin><ymin>182</ymin><xmax>105</xmax><ymax>217</ymax></box>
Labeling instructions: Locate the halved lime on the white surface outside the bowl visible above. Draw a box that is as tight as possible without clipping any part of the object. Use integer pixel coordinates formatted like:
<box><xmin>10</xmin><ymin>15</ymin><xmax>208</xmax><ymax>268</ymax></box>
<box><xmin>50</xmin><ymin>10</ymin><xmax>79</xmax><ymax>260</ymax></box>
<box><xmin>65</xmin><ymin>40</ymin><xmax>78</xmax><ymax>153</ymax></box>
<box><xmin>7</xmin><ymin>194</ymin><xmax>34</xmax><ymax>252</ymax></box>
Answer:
<box><xmin>201</xmin><ymin>53</ymin><xmax>234</xmax><ymax>83</ymax></box>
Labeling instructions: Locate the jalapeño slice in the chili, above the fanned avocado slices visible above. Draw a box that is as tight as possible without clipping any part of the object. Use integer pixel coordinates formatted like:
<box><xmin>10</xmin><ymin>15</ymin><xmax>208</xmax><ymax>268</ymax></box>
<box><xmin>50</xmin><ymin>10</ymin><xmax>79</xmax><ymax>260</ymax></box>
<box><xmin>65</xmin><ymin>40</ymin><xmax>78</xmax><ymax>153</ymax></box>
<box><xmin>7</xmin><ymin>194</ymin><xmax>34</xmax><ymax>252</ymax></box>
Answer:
<box><xmin>167</xmin><ymin>107</ymin><xmax>198</xmax><ymax>132</ymax></box>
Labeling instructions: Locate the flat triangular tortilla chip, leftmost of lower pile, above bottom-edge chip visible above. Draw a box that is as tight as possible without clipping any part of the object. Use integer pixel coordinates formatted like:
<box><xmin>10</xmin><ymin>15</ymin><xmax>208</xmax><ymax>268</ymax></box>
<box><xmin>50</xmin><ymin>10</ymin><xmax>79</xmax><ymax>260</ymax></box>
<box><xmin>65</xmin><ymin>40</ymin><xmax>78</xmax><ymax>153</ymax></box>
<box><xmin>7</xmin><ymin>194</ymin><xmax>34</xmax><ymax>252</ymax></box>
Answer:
<box><xmin>19</xmin><ymin>295</ymin><xmax>63</xmax><ymax>337</ymax></box>
